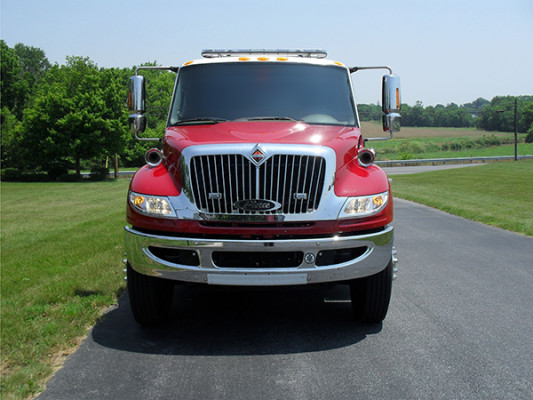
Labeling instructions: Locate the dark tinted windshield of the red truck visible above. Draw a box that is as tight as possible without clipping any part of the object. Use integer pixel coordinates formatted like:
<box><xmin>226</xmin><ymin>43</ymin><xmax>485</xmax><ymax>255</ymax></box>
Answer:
<box><xmin>169</xmin><ymin>62</ymin><xmax>357</xmax><ymax>126</ymax></box>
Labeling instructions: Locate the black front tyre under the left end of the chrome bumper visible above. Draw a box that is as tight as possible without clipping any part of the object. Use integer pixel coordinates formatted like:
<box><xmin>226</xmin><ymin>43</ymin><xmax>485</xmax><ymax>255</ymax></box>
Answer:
<box><xmin>127</xmin><ymin>264</ymin><xmax>174</xmax><ymax>326</ymax></box>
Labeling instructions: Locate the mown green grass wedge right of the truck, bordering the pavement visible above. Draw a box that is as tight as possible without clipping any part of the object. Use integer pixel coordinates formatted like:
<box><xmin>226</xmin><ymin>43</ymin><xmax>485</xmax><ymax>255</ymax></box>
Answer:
<box><xmin>392</xmin><ymin>160</ymin><xmax>533</xmax><ymax>236</ymax></box>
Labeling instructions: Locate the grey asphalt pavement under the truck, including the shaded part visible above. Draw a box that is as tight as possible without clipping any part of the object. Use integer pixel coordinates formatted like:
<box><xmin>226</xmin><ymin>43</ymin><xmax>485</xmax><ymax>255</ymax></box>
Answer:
<box><xmin>35</xmin><ymin>200</ymin><xmax>533</xmax><ymax>400</ymax></box>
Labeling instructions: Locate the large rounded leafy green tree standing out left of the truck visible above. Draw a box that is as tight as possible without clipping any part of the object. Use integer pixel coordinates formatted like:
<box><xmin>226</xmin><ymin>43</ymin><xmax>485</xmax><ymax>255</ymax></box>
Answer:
<box><xmin>21</xmin><ymin>57</ymin><xmax>126</xmax><ymax>175</ymax></box>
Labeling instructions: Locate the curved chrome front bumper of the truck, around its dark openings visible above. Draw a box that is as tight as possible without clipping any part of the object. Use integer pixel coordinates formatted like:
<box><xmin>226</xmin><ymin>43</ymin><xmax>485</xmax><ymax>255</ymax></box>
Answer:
<box><xmin>125</xmin><ymin>226</ymin><xmax>394</xmax><ymax>286</ymax></box>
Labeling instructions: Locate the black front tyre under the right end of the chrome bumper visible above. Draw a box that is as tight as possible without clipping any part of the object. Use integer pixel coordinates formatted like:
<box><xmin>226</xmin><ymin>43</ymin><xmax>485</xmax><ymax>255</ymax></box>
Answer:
<box><xmin>350</xmin><ymin>260</ymin><xmax>392</xmax><ymax>323</ymax></box>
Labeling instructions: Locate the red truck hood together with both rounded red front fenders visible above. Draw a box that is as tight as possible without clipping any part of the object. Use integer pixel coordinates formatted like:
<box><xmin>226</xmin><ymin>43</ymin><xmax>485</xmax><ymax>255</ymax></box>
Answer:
<box><xmin>132</xmin><ymin>121</ymin><xmax>390</xmax><ymax>202</ymax></box>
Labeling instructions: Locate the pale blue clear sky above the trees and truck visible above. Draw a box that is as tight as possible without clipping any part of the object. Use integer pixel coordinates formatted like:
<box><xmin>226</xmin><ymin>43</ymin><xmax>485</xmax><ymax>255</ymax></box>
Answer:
<box><xmin>0</xmin><ymin>0</ymin><xmax>533</xmax><ymax>106</ymax></box>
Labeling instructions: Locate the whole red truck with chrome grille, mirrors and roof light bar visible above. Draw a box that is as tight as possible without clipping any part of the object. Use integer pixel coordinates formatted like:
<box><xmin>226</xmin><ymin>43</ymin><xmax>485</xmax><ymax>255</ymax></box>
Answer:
<box><xmin>125</xmin><ymin>50</ymin><xmax>400</xmax><ymax>325</ymax></box>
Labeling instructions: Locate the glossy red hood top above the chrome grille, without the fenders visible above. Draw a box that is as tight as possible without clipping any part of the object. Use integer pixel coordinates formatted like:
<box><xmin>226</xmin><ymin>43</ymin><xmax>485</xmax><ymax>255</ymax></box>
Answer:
<box><xmin>163</xmin><ymin>121</ymin><xmax>361</xmax><ymax>169</ymax></box>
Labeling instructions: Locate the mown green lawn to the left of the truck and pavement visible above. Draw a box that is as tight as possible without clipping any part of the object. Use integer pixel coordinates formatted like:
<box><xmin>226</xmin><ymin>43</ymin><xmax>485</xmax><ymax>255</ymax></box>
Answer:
<box><xmin>1</xmin><ymin>179</ymin><xmax>129</xmax><ymax>399</ymax></box>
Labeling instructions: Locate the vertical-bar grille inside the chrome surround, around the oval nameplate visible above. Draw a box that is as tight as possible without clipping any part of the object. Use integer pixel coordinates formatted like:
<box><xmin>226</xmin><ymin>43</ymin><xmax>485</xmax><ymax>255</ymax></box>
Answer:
<box><xmin>190</xmin><ymin>154</ymin><xmax>326</xmax><ymax>215</ymax></box>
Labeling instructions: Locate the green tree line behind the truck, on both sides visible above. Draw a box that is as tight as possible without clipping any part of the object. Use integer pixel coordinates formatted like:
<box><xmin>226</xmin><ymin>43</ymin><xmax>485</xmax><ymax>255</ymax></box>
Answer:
<box><xmin>0</xmin><ymin>40</ymin><xmax>533</xmax><ymax>178</ymax></box>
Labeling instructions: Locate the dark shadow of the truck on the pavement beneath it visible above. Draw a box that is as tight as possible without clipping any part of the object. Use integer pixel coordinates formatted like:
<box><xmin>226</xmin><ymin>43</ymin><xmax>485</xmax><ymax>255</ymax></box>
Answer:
<box><xmin>92</xmin><ymin>285</ymin><xmax>382</xmax><ymax>356</ymax></box>
